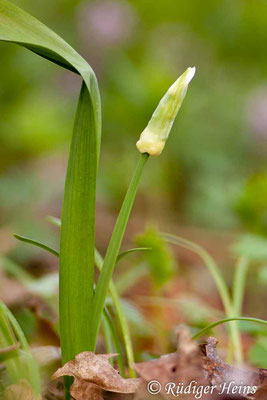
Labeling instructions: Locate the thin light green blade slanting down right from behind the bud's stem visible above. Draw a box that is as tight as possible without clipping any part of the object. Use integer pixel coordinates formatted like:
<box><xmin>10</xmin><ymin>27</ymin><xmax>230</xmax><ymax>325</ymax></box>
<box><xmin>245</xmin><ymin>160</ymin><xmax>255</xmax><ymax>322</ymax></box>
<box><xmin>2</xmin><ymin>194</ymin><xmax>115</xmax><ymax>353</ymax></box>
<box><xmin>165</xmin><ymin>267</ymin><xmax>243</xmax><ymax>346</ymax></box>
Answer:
<box><xmin>95</xmin><ymin>249</ymin><xmax>136</xmax><ymax>378</ymax></box>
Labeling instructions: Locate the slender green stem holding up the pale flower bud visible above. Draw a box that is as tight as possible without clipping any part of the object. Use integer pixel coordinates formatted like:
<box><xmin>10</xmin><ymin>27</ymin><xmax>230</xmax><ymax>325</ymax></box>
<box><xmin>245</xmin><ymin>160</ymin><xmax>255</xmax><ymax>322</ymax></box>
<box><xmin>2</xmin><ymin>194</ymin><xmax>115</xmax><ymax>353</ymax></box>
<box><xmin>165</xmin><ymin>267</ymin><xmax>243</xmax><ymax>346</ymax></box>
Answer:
<box><xmin>92</xmin><ymin>154</ymin><xmax>149</xmax><ymax>347</ymax></box>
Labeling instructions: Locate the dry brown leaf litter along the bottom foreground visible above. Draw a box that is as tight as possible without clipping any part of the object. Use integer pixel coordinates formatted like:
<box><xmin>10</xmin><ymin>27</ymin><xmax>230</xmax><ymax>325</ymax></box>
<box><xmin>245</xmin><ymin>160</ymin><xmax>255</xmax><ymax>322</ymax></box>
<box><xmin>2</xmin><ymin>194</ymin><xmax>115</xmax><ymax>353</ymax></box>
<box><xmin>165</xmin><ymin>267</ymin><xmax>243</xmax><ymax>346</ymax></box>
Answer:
<box><xmin>50</xmin><ymin>326</ymin><xmax>267</xmax><ymax>400</ymax></box>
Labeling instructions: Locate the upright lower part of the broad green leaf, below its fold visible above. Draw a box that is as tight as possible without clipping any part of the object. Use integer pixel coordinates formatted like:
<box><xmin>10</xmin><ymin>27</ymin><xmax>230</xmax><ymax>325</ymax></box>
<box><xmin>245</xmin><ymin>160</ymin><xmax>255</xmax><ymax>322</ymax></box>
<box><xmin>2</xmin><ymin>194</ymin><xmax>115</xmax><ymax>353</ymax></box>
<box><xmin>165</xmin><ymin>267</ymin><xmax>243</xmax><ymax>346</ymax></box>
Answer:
<box><xmin>59</xmin><ymin>85</ymin><xmax>97</xmax><ymax>363</ymax></box>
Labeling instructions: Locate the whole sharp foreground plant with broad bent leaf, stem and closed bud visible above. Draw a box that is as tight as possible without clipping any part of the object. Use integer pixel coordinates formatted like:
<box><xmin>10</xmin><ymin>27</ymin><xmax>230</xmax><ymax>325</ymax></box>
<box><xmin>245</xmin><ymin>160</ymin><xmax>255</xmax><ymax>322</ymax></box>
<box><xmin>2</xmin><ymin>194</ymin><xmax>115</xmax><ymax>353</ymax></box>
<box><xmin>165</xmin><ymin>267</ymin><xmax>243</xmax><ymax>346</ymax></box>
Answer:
<box><xmin>0</xmin><ymin>0</ymin><xmax>195</xmax><ymax>397</ymax></box>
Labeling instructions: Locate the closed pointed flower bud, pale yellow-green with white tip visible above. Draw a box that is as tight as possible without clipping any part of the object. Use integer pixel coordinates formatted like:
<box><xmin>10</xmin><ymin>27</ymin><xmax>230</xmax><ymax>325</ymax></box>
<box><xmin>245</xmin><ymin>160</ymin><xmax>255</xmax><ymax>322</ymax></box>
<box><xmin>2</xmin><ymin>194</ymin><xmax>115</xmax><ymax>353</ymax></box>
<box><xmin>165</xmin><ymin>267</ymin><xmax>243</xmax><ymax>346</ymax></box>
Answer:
<box><xmin>136</xmin><ymin>67</ymin><xmax>196</xmax><ymax>156</ymax></box>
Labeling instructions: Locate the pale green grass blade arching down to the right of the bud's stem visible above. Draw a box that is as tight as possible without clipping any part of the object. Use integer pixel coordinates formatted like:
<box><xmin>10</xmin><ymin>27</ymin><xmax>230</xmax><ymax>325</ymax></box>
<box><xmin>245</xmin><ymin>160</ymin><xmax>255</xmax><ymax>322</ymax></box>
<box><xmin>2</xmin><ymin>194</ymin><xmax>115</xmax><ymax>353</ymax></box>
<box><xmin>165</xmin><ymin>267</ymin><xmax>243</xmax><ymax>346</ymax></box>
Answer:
<box><xmin>161</xmin><ymin>233</ymin><xmax>242</xmax><ymax>365</ymax></box>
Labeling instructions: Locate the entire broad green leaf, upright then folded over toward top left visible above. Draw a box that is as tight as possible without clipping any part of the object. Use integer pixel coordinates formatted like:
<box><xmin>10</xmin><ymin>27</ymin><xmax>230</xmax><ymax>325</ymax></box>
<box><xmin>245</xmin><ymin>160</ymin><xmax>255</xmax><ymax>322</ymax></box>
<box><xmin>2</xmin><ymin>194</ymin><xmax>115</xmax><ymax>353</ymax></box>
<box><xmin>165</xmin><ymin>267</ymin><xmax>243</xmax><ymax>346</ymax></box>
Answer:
<box><xmin>0</xmin><ymin>0</ymin><xmax>101</xmax><ymax>376</ymax></box>
